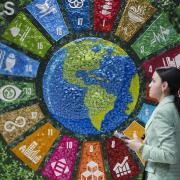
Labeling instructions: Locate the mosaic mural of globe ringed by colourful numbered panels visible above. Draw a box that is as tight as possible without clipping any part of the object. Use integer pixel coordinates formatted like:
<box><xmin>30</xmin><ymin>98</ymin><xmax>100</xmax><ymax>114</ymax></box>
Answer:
<box><xmin>0</xmin><ymin>0</ymin><xmax>180</xmax><ymax>180</ymax></box>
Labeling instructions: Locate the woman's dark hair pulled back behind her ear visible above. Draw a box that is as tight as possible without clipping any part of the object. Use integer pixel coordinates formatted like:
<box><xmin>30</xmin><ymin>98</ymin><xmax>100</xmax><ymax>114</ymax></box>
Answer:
<box><xmin>156</xmin><ymin>67</ymin><xmax>180</xmax><ymax>113</ymax></box>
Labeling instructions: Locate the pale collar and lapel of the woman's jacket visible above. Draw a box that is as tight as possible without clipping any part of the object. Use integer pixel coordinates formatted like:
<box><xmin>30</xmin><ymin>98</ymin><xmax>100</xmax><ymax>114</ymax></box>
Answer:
<box><xmin>145</xmin><ymin>95</ymin><xmax>174</xmax><ymax>130</ymax></box>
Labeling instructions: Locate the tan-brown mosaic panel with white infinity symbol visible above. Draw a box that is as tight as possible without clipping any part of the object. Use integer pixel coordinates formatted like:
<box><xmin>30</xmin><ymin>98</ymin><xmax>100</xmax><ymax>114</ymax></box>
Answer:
<box><xmin>0</xmin><ymin>104</ymin><xmax>44</xmax><ymax>144</ymax></box>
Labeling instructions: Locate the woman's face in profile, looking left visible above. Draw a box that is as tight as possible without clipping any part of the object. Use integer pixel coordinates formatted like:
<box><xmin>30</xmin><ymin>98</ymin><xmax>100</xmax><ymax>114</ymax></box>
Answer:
<box><xmin>149</xmin><ymin>71</ymin><xmax>162</xmax><ymax>100</ymax></box>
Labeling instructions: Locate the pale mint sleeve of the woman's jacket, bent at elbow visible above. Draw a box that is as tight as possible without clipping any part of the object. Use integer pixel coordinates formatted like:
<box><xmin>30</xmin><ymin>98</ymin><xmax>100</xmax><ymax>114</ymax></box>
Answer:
<box><xmin>142</xmin><ymin>109</ymin><xmax>177</xmax><ymax>164</ymax></box>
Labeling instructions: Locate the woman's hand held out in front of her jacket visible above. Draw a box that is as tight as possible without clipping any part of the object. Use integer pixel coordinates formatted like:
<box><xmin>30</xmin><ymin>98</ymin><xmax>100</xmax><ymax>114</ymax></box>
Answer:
<box><xmin>123</xmin><ymin>131</ymin><xmax>143</xmax><ymax>152</ymax></box>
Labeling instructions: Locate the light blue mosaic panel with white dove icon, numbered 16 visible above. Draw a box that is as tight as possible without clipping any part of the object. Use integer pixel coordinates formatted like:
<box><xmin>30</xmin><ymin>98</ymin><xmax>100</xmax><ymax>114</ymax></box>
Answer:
<box><xmin>26</xmin><ymin>0</ymin><xmax>69</xmax><ymax>41</ymax></box>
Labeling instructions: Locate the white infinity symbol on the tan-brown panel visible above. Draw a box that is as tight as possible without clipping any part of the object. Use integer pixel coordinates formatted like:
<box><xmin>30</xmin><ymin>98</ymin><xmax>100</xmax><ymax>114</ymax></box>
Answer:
<box><xmin>4</xmin><ymin>116</ymin><xmax>26</xmax><ymax>132</ymax></box>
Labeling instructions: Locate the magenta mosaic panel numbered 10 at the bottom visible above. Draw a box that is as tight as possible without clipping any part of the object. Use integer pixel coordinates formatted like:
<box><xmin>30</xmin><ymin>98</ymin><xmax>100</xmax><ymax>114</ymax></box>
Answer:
<box><xmin>41</xmin><ymin>136</ymin><xmax>79</xmax><ymax>180</ymax></box>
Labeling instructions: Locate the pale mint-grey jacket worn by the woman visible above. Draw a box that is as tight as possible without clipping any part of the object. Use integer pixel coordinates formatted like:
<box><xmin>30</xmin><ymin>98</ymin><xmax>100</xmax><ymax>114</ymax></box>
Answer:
<box><xmin>142</xmin><ymin>96</ymin><xmax>180</xmax><ymax>180</ymax></box>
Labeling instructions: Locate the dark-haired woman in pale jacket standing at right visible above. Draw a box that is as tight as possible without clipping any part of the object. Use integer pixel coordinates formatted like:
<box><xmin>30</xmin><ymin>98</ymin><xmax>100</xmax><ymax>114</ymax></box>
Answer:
<box><xmin>124</xmin><ymin>67</ymin><xmax>180</xmax><ymax>180</ymax></box>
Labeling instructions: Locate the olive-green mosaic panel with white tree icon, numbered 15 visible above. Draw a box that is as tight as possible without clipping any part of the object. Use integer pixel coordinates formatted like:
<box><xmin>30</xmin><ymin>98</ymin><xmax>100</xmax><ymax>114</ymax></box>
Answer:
<box><xmin>2</xmin><ymin>13</ymin><xmax>51</xmax><ymax>57</ymax></box>
